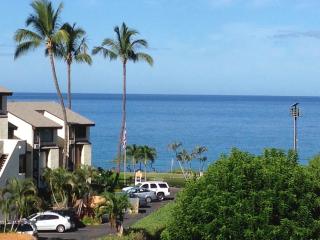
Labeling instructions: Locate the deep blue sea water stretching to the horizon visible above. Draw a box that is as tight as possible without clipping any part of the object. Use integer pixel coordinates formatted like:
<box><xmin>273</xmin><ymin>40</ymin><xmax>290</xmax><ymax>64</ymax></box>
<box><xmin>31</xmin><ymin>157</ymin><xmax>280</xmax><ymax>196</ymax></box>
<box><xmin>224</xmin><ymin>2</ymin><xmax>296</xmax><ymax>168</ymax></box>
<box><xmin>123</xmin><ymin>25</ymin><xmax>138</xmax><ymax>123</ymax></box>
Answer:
<box><xmin>10</xmin><ymin>93</ymin><xmax>320</xmax><ymax>171</ymax></box>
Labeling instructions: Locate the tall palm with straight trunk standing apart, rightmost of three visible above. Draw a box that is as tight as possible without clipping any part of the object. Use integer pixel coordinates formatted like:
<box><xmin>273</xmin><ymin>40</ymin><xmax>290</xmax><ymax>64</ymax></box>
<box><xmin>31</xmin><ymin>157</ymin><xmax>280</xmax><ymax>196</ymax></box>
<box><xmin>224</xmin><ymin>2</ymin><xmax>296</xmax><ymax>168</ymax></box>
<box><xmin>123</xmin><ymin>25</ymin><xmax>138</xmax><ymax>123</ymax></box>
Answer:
<box><xmin>92</xmin><ymin>23</ymin><xmax>153</xmax><ymax>173</ymax></box>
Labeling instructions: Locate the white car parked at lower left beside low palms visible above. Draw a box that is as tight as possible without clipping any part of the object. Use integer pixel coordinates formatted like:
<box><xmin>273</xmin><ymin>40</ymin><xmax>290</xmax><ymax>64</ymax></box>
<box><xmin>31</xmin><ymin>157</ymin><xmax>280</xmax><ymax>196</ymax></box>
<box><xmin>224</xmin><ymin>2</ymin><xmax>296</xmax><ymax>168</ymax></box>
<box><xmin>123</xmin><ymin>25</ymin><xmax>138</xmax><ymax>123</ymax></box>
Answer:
<box><xmin>28</xmin><ymin>211</ymin><xmax>71</xmax><ymax>233</ymax></box>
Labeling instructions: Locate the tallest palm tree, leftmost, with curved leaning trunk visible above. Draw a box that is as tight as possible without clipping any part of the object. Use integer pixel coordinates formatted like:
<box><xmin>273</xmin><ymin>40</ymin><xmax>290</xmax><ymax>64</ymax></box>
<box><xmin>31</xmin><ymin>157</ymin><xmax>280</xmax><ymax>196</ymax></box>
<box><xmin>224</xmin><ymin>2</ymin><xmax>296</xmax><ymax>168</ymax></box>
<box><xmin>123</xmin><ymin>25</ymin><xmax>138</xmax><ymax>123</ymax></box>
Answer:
<box><xmin>14</xmin><ymin>0</ymin><xmax>69</xmax><ymax>167</ymax></box>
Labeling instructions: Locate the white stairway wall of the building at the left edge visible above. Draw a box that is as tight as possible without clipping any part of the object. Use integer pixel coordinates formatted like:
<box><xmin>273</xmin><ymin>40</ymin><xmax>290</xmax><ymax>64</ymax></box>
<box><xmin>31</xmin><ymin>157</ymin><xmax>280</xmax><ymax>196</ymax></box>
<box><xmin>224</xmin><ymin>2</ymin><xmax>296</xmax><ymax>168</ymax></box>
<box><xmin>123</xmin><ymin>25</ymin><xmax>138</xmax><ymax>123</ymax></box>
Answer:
<box><xmin>0</xmin><ymin>139</ymin><xmax>26</xmax><ymax>187</ymax></box>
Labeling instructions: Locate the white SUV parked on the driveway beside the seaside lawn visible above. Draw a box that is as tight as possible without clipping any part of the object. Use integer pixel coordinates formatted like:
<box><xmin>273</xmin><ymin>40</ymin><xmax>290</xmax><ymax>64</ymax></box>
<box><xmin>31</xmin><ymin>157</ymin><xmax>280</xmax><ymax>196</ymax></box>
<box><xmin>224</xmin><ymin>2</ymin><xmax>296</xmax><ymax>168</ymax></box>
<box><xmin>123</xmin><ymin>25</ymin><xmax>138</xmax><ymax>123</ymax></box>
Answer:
<box><xmin>122</xmin><ymin>181</ymin><xmax>170</xmax><ymax>201</ymax></box>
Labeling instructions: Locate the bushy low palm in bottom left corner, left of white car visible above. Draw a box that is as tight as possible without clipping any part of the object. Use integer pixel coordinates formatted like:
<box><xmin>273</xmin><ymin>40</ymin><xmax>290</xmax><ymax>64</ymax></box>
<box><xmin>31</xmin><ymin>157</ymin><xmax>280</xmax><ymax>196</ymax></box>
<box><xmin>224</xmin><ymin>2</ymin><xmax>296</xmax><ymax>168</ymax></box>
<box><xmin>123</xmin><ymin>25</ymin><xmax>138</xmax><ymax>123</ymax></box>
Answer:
<box><xmin>1</xmin><ymin>178</ymin><xmax>40</xmax><ymax>226</ymax></box>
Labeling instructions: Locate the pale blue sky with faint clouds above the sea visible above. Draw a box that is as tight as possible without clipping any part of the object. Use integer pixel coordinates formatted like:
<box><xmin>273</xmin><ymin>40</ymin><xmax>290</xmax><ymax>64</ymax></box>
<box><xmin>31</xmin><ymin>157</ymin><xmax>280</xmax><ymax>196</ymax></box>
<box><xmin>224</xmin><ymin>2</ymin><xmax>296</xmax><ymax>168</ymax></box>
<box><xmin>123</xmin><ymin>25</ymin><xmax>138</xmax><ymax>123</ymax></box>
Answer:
<box><xmin>0</xmin><ymin>0</ymin><xmax>320</xmax><ymax>96</ymax></box>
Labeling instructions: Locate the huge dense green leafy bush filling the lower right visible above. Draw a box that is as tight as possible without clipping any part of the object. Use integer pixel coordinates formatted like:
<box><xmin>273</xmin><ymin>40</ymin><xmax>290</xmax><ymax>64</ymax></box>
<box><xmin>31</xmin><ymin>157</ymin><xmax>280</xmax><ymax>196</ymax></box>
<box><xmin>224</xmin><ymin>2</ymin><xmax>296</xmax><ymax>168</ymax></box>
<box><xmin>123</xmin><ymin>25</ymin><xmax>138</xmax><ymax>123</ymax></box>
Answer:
<box><xmin>163</xmin><ymin>149</ymin><xmax>320</xmax><ymax>240</ymax></box>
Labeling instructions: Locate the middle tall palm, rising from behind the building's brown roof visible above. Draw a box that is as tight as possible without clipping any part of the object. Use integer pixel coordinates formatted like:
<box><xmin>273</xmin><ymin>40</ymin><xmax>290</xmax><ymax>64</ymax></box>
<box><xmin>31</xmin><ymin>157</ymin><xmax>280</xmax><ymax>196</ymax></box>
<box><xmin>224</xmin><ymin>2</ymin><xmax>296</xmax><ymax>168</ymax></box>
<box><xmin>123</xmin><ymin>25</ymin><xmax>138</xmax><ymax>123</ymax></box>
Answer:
<box><xmin>58</xmin><ymin>23</ymin><xmax>92</xmax><ymax>109</ymax></box>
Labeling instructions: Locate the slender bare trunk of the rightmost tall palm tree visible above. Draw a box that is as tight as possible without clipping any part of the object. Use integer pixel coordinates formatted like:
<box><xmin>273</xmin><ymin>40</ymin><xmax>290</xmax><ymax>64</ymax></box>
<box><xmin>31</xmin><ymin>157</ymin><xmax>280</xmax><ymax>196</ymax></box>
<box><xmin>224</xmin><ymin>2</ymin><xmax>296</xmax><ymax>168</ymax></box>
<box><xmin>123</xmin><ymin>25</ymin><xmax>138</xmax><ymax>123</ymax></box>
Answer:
<box><xmin>117</xmin><ymin>61</ymin><xmax>127</xmax><ymax>173</ymax></box>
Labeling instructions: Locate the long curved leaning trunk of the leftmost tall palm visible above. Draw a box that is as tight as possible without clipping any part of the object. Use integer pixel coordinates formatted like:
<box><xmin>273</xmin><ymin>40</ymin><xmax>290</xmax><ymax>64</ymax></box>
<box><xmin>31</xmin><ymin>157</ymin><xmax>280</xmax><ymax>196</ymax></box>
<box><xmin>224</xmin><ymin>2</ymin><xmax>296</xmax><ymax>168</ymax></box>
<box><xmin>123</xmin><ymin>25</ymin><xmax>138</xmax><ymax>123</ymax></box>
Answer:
<box><xmin>49</xmin><ymin>49</ymin><xmax>69</xmax><ymax>168</ymax></box>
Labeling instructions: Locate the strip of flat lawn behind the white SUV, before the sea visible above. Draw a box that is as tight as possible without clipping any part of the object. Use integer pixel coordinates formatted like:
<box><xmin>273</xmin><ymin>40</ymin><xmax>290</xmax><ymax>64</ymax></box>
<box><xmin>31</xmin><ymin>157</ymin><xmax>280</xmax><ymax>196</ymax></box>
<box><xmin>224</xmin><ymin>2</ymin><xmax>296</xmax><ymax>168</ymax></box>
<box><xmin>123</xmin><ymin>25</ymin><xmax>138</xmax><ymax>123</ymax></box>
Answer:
<box><xmin>119</xmin><ymin>172</ymin><xmax>185</xmax><ymax>188</ymax></box>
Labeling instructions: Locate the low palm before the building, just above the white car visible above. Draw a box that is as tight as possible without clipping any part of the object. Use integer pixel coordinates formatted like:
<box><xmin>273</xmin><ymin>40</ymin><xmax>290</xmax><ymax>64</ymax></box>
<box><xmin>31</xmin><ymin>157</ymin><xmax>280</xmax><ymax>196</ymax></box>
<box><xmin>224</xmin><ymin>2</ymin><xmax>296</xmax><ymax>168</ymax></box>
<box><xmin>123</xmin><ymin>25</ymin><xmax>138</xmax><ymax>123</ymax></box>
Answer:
<box><xmin>43</xmin><ymin>168</ymin><xmax>75</xmax><ymax>208</ymax></box>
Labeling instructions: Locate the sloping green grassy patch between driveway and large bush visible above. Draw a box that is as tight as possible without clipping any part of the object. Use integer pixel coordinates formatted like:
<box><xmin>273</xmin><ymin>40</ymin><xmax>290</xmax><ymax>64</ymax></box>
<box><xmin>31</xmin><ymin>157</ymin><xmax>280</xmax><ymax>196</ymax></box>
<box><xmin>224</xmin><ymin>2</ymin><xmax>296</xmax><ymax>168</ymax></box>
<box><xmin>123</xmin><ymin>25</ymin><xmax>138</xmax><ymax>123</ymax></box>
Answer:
<box><xmin>130</xmin><ymin>202</ymin><xmax>175</xmax><ymax>239</ymax></box>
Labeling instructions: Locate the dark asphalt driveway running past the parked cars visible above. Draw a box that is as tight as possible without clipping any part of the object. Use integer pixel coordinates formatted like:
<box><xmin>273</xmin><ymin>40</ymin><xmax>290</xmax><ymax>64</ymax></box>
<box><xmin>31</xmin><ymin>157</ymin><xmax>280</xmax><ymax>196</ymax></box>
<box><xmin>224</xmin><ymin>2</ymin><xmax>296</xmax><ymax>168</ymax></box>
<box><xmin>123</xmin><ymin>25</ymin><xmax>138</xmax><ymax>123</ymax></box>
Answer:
<box><xmin>39</xmin><ymin>188</ymin><xmax>179</xmax><ymax>240</ymax></box>
